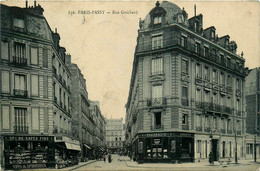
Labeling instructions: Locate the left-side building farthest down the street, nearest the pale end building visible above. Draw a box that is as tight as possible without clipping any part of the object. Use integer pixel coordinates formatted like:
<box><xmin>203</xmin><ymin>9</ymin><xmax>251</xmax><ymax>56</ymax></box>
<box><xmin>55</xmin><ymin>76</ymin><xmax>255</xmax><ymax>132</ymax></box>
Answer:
<box><xmin>90</xmin><ymin>101</ymin><xmax>106</xmax><ymax>157</ymax></box>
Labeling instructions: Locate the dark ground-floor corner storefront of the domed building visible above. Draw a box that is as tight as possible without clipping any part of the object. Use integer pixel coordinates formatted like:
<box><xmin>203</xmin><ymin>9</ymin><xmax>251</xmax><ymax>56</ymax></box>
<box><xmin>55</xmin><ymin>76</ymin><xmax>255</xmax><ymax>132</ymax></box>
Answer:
<box><xmin>132</xmin><ymin>132</ymin><xmax>194</xmax><ymax>163</ymax></box>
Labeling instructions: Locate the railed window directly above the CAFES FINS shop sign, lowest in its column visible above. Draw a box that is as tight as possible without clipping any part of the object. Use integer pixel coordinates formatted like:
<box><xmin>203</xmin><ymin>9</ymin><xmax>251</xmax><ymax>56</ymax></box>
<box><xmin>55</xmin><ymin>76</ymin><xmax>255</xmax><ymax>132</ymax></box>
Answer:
<box><xmin>14</xmin><ymin>107</ymin><xmax>27</xmax><ymax>132</ymax></box>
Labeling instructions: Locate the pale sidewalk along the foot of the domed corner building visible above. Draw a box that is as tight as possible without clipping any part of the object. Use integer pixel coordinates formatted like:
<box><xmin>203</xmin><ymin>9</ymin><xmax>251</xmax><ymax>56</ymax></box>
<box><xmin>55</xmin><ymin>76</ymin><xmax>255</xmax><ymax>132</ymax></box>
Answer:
<box><xmin>121</xmin><ymin>156</ymin><xmax>260</xmax><ymax>169</ymax></box>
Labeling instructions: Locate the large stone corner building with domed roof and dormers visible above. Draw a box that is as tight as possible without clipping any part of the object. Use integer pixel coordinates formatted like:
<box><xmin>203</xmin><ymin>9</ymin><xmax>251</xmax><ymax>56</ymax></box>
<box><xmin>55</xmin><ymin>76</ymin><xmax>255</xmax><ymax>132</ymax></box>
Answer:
<box><xmin>125</xmin><ymin>1</ymin><xmax>247</xmax><ymax>163</ymax></box>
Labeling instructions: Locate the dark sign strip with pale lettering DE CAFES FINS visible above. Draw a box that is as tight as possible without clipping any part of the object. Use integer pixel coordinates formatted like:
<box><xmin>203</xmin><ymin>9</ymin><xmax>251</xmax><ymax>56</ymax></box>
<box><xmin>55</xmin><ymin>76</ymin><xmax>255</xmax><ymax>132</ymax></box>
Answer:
<box><xmin>5</xmin><ymin>136</ymin><xmax>54</xmax><ymax>141</ymax></box>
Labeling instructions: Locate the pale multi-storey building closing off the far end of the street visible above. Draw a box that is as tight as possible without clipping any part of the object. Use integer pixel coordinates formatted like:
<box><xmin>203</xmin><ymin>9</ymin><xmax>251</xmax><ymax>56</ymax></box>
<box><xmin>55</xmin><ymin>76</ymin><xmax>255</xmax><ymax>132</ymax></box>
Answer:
<box><xmin>106</xmin><ymin>118</ymin><xmax>125</xmax><ymax>153</ymax></box>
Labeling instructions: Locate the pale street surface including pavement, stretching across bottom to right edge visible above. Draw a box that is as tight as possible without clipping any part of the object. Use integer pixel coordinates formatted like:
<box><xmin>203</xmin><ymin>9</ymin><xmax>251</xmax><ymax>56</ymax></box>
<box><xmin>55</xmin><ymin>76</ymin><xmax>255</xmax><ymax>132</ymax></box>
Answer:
<box><xmin>68</xmin><ymin>154</ymin><xmax>260</xmax><ymax>171</ymax></box>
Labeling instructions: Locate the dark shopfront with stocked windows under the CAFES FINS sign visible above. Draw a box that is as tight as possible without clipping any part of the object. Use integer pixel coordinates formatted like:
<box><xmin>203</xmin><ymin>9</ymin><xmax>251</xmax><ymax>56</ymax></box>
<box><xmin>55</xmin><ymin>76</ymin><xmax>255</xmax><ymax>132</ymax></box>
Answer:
<box><xmin>4</xmin><ymin>135</ymin><xmax>55</xmax><ymax>170</ymax></box>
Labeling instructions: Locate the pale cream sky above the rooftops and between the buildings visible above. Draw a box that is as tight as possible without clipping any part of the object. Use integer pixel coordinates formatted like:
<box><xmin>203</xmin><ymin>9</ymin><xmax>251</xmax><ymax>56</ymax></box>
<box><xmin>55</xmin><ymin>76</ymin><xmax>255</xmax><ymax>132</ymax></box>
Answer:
<box><xmin>1</xmin><ymin>0</ymin><xmax>260</xmax><ymax>119</ymax></box>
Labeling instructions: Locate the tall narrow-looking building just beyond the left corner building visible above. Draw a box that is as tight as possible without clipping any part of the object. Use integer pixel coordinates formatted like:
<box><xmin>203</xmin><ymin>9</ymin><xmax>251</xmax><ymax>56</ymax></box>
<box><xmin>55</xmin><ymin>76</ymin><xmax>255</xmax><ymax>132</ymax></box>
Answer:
<box><xmin>66</xmin><ymin>54</ymin><xmax>93</xmax><ymax>161</ymax></box>
